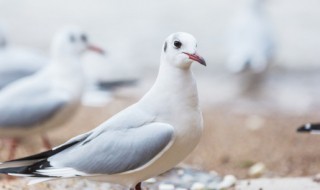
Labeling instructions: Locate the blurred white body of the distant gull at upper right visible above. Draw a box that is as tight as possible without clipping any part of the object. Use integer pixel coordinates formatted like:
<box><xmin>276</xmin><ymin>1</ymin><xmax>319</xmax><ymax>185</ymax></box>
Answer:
<box><xmin>227</xmin><ymin>0</ymin><xmax>274</xmax><ymax>73</ymax></box>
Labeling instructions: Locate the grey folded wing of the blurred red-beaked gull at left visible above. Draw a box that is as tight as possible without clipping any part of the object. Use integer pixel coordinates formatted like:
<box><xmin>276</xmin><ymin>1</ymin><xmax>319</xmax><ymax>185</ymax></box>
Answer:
<box><xmin>0</xmin><ymin>82</ymin><xmax>67</xmax><ymax>128</ymax></box>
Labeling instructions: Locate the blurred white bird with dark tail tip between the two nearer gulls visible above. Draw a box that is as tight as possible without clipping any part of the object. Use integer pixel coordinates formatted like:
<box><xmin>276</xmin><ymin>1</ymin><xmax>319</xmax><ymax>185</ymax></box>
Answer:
<box><xmin>82</xmin><ymin>46</ymin><xmax>138</xmax><ymax>107</ymax></box>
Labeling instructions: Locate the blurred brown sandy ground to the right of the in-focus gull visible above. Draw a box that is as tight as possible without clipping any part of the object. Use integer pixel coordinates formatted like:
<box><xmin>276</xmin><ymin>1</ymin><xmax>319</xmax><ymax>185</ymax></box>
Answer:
<box><xmin>188</xmin><ymin>107</ymin><xmax>320</xmax><ymax>178</ymax></box>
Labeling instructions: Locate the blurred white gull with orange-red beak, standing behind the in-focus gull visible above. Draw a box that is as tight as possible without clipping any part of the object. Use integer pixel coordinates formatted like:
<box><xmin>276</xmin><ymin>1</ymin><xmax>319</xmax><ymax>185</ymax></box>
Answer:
<box><xmin>0</xmin><ymin>27</ymin><xmax>102</xmax><ymax>159</ymax></box>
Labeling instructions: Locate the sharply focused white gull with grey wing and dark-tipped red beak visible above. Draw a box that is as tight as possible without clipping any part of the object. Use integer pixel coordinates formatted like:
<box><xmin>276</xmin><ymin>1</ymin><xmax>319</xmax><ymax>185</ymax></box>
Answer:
<box><xmin>0</xmin><ymin>32</ymin><xmax>206</xmax><ymax>189</ymax></box>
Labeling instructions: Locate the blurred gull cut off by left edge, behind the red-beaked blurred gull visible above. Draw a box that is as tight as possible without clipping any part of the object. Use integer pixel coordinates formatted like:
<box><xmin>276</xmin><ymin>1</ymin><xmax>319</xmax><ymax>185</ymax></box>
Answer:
<box><xmin>0</xmin><ymin>27</ymin><xmax>49</xmax><ymax>89</ymax></box>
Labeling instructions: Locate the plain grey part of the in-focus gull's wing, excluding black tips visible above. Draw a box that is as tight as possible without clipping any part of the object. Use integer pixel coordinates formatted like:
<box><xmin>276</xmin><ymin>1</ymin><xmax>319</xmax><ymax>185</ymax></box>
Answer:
<box><xmin>49</xmin><ymin>123</ymin><xmax>174</xmax><ymax>174</ymax></box>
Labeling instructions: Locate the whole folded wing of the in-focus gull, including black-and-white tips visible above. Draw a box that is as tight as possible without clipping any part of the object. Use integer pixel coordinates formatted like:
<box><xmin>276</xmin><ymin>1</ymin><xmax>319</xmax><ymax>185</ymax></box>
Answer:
<box><xmin>0</xmin><ymin>122</ymin><xmax>174</xmax><ymax>178</ymax></box>
